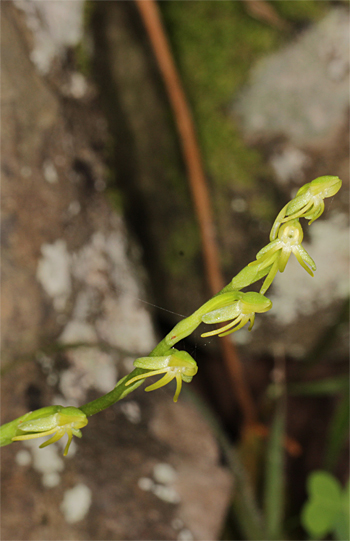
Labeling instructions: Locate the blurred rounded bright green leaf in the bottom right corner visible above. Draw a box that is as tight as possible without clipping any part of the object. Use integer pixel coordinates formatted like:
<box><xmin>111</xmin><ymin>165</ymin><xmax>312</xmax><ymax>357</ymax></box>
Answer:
<box><xmin>301</xmin><ymin>470</ymin><xmax>349</xmax><ymax>541</ymax></box>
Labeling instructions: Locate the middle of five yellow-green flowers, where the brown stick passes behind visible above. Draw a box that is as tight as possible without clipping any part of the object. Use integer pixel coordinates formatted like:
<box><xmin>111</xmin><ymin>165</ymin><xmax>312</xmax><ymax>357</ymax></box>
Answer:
<box><xmin>202</xmin><ymin>291</ymin><xmax>272</xmax><ymax>337</ymax></box>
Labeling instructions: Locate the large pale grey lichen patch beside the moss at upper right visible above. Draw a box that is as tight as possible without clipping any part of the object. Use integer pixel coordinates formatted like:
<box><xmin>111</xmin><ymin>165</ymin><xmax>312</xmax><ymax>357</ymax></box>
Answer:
<box><xmin>235</xmin><ymin>8</ymin><xmax>349</xmax><ymax>145</ymax></box>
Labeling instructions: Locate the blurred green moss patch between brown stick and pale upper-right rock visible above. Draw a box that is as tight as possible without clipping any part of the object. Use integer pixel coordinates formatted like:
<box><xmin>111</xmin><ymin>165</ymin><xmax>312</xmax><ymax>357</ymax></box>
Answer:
<box><xmin>160</xmin><ymin>1</ymin><xmax>282</xmax><ymax>193</ymax></box>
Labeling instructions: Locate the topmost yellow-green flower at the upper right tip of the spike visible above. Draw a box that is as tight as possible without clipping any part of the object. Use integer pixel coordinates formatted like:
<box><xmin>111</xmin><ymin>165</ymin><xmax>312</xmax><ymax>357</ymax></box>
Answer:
<box><xmin>270</xmin><ymin>176</ymin><xmax>342</xmax><ymax>240</ymax></box>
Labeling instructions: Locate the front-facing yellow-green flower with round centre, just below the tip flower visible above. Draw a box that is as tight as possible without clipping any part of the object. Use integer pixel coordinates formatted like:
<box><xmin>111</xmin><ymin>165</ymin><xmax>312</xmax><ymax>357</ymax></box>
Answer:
<box><xmin>248</xmin><ymin>220</ymin><xmax>316</xmax><ymax>294</ymax></box>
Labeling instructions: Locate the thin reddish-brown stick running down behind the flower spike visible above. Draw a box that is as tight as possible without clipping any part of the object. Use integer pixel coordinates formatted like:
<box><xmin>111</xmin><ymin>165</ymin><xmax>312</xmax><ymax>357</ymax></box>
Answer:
<box><xmin>135</xmin><ymin>0</ymin><xmax>256</xmax><ymax>426</ymax></box>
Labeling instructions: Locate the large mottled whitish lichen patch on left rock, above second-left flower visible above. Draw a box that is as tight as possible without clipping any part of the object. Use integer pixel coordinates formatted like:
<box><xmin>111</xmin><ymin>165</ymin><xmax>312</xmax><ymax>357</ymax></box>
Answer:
<box><xmin>72</xmin><ymin>230</ymin><xmax>155</xmax><ymax>354</ymax></box>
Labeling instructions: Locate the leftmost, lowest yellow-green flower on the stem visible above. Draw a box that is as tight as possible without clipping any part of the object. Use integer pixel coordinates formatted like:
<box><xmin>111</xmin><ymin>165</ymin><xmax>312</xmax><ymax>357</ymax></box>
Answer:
<box><xmin>6</xmin><ymin>406</ymin><xmax>88</xmax><ymax>456</ymax></box>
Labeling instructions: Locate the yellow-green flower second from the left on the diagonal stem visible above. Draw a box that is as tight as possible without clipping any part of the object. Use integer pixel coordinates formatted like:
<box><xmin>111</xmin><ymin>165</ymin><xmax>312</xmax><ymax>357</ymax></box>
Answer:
<box><xmin>125</xmin><ymin>349</ymin><xmax>198</xmax><ymax>402</ymax></box>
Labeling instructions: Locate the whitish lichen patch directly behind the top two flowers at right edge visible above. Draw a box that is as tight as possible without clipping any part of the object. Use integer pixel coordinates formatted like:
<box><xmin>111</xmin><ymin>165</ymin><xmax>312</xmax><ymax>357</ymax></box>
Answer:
<box><xmin>267</xmin><ymin>214</ymin><xmax>349</xmax><ymax>325</ymax></box>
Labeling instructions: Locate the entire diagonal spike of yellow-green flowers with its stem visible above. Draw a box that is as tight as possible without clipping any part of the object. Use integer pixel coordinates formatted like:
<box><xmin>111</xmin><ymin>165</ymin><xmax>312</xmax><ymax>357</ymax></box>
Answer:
<box><xmin>0</xmin><ymin>176</ymin><xmax>342</xmax><ymax>455</ymax></box>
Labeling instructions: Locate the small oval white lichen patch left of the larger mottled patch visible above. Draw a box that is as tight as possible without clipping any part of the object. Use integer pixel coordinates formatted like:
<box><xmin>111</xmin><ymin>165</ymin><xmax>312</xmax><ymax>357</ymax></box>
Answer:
<box><xmin>36</xmin><ymin>239</ymin><xmax>72</xmax><ymax>311</ymax></box>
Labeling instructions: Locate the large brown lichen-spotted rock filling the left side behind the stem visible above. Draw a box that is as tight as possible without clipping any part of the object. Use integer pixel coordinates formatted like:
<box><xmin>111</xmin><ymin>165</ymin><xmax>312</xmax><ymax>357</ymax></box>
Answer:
<box><xmin>1</xmin><ymin>2</ymin><xmax>231</xmax><ymax>540</ymax></box>
